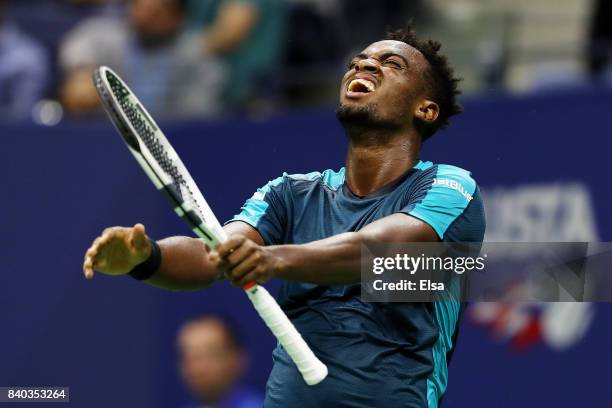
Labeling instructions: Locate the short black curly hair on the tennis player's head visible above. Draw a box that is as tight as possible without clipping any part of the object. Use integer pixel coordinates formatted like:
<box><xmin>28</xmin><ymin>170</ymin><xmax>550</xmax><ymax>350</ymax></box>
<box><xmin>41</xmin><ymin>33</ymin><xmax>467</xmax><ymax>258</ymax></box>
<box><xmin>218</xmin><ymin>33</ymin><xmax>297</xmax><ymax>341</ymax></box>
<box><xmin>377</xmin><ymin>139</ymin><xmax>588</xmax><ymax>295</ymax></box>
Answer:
<box><xmin>386</xmin><ymin>24</ymin><xmax>463</xmax><ymax>140</ymax></box>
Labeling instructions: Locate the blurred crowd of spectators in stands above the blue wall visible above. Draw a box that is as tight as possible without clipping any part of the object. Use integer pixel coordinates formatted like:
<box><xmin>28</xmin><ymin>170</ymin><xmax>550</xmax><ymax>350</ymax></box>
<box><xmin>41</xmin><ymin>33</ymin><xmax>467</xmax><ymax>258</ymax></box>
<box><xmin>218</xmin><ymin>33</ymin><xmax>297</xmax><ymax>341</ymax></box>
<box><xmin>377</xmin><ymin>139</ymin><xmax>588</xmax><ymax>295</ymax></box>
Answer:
<box><xmin>0</xmin><ymin>0</ymin><xmax>612</xmax><ymax>124</ymax></box>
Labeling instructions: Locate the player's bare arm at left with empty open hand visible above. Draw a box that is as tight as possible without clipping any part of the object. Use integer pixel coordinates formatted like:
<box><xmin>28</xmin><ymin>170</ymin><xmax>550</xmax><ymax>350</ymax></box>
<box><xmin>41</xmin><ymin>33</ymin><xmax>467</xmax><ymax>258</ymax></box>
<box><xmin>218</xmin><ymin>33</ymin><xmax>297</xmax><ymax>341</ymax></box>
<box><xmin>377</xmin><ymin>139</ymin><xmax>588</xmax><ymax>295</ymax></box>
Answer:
<box><xmin>83</xmin><ymin>222</ymin><xmax>264</xmax><ymax>291</ymax></box>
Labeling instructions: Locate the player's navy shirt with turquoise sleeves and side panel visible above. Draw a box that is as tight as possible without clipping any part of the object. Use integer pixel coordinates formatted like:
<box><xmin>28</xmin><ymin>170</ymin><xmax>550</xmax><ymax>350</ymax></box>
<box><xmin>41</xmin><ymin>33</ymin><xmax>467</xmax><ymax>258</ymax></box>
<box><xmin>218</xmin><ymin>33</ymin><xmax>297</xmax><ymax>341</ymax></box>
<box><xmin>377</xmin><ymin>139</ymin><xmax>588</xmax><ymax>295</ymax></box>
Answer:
<box><xmin>227</xmin><ymin>161</ymin><xmax>485</xmax><ymax>408</ymax></box>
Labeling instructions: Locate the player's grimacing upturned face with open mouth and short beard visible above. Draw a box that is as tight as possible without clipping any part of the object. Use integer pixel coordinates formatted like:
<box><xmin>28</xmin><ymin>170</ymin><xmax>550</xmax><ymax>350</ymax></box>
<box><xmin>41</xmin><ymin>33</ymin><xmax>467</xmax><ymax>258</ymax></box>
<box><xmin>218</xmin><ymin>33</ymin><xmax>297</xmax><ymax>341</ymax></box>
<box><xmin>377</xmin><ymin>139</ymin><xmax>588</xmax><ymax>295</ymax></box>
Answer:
<box><xmin>337</xmin><ymin>40</ymin><xmax>429</xmax><ymax>127</ymax></box>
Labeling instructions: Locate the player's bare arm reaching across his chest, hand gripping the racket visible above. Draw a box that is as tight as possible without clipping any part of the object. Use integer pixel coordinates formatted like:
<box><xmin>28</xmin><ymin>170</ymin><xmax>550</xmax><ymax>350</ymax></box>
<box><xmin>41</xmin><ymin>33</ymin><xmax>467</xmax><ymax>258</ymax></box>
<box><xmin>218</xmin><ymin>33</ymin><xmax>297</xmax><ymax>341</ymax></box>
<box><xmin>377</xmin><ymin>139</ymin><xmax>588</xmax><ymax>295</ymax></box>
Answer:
<box><xmin>218</xmin><ymin>213</ymin><xmax>439</xmax><ymax>286</ymax></box>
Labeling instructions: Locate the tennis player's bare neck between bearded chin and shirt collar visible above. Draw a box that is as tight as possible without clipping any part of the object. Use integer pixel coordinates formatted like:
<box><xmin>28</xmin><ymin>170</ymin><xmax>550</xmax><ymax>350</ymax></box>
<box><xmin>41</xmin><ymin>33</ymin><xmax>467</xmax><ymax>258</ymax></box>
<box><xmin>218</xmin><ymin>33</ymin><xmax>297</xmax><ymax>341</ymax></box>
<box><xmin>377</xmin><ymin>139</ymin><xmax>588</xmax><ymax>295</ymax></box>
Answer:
<box><xmin>346</xmin><ymin>129</ymin><xmax>421</xmax><ymax>197</ymax></box>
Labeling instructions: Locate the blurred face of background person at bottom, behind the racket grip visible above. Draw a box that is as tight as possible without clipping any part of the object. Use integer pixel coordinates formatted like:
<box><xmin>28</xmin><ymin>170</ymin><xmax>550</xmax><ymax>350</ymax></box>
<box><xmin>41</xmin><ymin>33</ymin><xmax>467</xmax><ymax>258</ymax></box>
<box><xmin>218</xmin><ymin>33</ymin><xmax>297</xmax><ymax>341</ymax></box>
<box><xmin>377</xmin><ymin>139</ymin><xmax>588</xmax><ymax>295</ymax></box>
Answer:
<box><xmin>178</xmin><ymin>320</ymin><xmax>243</xmax><ymax>399</ymax></box>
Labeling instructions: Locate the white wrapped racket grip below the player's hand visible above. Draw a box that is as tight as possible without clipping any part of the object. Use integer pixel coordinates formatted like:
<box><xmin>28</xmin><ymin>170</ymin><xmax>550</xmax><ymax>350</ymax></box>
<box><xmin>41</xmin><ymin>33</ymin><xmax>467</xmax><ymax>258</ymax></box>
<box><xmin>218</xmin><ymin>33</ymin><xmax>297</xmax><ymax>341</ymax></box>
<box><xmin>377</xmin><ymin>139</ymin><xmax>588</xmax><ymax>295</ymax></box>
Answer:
<box><xmin>245</xmin><ymin>285</ymin><xmax>327</xmax><ymax>385</ymax></box>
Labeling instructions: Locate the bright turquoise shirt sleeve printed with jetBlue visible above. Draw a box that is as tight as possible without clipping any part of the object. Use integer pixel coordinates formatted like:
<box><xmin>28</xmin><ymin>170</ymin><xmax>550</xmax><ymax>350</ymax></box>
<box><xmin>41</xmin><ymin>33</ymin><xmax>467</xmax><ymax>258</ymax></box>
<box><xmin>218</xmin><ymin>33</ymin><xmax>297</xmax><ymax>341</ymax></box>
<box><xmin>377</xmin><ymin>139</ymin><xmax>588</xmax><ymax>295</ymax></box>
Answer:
<box><xmin>400</xmin><ymin>165</ymin><xmax>484</xmax><ymax>241</ymax></box>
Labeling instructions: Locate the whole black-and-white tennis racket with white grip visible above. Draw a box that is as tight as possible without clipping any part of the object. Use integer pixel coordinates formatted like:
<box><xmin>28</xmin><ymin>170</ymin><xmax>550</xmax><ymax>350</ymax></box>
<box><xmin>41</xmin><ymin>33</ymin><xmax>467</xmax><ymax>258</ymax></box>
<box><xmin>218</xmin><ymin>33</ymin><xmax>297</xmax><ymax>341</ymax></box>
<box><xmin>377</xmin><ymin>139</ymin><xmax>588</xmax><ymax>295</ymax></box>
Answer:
<box><xmin>93</xmin><ymin>67</ymin><xmax>327</xmax><ymax>385</ymax></box>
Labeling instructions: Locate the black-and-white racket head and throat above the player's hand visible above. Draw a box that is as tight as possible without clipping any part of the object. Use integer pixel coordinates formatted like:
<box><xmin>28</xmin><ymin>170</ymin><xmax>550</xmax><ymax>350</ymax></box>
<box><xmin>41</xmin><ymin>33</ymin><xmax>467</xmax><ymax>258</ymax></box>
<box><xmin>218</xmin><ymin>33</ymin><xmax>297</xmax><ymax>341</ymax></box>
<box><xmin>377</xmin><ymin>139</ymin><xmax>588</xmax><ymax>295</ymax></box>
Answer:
<box><xmin>93</xmin><ymin>66</ymin><xmax>226</xmax><ymax>248</ymax></box>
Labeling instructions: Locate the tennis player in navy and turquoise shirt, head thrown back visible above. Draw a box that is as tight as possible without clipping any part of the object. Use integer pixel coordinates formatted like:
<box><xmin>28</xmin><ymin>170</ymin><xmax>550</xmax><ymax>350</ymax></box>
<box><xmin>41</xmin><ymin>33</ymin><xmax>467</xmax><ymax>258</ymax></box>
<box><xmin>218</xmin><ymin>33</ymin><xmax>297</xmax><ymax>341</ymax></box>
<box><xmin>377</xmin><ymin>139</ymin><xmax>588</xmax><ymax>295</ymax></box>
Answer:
<box><xmin>83</xmin><ymin>29</ymin><xmax>485</xmax><ymax>408</ymax></box>
